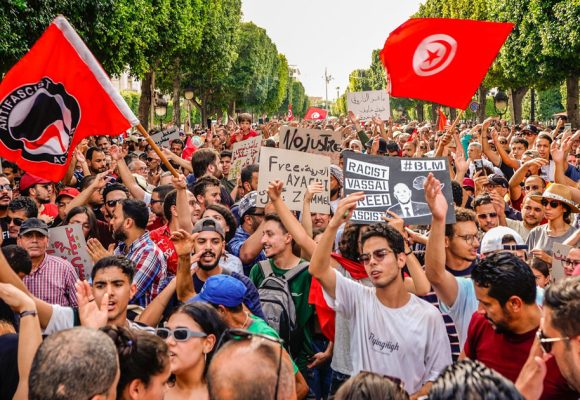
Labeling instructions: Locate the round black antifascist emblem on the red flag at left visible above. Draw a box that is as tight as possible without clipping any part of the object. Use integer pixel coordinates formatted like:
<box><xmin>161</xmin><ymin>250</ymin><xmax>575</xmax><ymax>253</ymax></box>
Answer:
<box><xmin>0</xmin><ymin>77</ymin><xmax>81</xmax><ymax>165</ymax></box>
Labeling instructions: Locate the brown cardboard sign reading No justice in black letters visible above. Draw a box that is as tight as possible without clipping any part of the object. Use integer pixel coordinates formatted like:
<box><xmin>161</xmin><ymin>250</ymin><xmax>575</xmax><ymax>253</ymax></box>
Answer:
<box><xmin>280</xmin><ymin>126</ymin><xmax>342</xmax><ymax>165</ymax></box>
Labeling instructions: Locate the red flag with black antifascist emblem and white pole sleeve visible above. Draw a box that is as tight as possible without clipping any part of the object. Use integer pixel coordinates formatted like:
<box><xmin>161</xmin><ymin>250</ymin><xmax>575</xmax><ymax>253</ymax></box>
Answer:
<box><xmin>0</xmin><ymin>16</ymin><xmax>139</xmax><ymax>182</ymax></box>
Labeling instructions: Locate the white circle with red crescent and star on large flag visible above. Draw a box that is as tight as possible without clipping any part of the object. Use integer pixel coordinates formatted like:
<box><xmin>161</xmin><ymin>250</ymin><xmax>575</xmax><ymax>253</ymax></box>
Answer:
<box><xmin>413</xmin><ymin>33</ymin><xmax>457</xmax><ymax>76</ymax></box>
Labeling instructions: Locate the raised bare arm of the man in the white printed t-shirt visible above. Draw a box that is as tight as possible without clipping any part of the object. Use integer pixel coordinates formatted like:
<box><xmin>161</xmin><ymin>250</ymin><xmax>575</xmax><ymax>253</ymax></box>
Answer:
<box><xmin>308</xmin><ymin>192</ymin><xmax>364</xmax><ymax>298</ymax></box>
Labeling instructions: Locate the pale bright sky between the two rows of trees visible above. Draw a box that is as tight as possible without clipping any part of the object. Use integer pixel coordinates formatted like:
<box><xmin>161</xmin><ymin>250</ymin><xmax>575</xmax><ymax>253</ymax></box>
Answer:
<box><xmin>242</xmin><ymin>0</ymin><xmax>421</xmax><ymax>100</ymax></box>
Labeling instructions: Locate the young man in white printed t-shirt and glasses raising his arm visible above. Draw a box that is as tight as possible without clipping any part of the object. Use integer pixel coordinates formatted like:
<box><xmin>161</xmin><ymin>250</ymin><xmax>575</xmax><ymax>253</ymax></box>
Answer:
<box><xmin>309</xmin><ymin>193</ymin><xmax>451</xmax><ymax>396</ymax></box>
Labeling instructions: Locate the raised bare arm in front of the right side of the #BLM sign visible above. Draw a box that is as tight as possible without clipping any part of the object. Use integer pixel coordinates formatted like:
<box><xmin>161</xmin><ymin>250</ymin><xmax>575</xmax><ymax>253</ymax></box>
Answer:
<box><xmin>424</xmin><ymin>174</ymin><xmax>458</xmax><ymax>306</ymax></box>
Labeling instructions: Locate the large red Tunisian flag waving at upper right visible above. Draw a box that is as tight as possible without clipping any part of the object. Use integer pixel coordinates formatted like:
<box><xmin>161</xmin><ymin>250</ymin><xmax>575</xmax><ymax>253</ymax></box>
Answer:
<box><xmin>381</xmin><ymin>18</ymin><xmax>514</xmax><ymax>110</ymax></box>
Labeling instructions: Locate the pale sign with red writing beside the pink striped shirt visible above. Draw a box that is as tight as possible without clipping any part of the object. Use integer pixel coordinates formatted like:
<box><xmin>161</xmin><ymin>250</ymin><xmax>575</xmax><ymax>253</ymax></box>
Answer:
<box><xmin>46</xmin><ymin>224</ymin><xmax>93</xmax><ymax>280</ymax></box>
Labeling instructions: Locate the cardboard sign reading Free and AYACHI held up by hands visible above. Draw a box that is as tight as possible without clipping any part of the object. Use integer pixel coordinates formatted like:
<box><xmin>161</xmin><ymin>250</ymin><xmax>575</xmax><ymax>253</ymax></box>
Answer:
<box><xmin>257</xmin><ymin>147</ymin><xmax>330</xmax><ymax>214</ymax></box>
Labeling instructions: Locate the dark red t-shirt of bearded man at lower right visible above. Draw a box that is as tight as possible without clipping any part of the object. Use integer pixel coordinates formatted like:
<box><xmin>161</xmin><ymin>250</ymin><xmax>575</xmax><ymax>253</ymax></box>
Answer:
<box><xmin>463</xmin><ymin>312</ymin><xmax>578</xmax><ymax>400</ymax></box>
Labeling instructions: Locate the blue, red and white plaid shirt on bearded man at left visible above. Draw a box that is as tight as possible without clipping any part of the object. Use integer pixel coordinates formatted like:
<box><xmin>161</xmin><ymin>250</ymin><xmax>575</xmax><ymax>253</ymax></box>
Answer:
<box><xmin>115</xmin><ymin>231</ymin><xmax>167</xmax><ymax>307</ymax></box>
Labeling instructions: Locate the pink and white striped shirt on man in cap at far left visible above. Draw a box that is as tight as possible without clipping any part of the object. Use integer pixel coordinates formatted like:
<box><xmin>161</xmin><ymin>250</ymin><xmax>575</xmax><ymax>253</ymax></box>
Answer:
<box><xmin>22</xmin><ymin>254</ymin><xmax>79</xmax><ymax>307</ymax></box>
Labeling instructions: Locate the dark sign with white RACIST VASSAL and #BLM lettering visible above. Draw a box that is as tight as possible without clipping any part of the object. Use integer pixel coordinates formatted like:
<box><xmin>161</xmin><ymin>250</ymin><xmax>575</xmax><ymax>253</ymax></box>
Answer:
<box><xmin>344</xmin><ymin>151</ymin><xmax>455</xmax><ymax>225</ymax></box>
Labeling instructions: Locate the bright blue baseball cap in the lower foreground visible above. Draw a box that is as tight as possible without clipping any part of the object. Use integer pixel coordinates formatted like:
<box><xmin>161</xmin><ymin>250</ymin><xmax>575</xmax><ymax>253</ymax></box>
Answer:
<box><xmin>188</xmin><ymin>274</ymin><xmax>247</xmax><ymax>307</ymax></box>
